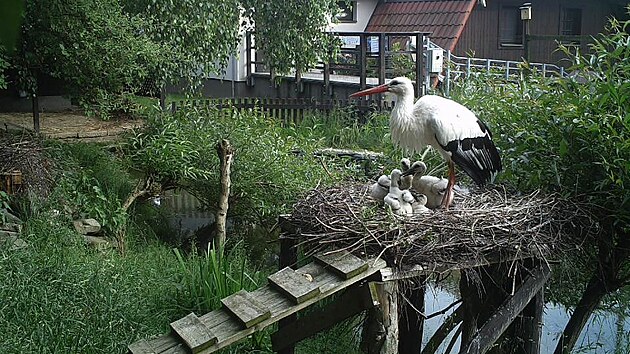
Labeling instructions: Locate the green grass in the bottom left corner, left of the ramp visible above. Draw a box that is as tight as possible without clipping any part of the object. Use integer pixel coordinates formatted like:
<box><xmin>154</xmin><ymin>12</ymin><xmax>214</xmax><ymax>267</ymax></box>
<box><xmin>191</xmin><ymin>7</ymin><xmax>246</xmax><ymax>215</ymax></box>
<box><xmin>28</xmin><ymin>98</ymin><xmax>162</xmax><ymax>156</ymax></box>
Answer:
<box><xmin>0</xmin><ymin>217</ymin><xmax>186</xmax><ymax>353</ymax></box>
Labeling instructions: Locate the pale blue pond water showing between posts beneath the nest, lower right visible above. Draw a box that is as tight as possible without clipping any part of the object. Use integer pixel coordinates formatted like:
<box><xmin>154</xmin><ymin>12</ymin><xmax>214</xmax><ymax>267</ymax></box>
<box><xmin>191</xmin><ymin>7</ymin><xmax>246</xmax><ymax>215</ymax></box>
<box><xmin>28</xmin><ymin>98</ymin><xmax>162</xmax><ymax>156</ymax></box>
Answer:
<box><xmin>423</xmin><ymin>285</ymin><xmax>630</xmax><ymax>354</ymax></box>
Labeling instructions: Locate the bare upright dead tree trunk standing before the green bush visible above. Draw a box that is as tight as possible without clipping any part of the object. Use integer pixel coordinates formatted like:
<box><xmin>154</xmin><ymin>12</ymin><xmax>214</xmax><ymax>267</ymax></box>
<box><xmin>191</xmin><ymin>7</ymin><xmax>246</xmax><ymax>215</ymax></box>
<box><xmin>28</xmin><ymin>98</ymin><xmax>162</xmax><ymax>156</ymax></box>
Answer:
<box><xmin>214</xmin><ymin>139</ymin><xmax>234</xmax><ymax>248</ymax></box>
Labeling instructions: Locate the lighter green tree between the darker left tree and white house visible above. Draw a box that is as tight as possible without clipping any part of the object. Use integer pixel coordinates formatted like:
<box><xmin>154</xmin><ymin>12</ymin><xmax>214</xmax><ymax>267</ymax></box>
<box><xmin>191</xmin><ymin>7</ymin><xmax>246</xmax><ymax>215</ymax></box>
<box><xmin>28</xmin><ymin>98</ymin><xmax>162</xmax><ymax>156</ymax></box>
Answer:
<box><xmin>124</xmin><ymin>0</ymin><xmax>241</xmax><ymax>89</ymax></box>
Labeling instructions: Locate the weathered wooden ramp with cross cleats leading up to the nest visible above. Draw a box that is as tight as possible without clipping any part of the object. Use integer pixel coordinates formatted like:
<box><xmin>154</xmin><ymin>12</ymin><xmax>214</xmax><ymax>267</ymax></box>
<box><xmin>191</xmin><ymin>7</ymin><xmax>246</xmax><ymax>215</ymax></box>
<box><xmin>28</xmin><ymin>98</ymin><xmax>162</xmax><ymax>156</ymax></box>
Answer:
<box><xmin>129</xmin><ymin>254</ymin><xmax>386</xmax><ymax>354</ymax></box>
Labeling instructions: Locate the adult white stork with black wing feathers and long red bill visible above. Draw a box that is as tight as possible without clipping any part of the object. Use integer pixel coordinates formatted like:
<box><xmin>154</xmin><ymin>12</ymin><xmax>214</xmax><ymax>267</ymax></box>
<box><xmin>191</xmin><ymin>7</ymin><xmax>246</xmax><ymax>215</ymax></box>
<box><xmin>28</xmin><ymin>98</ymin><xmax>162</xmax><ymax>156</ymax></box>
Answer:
<box><xmin>350</xmin><ymin>77</ymin><xmax>501</xmax><ymax>208</ymax></box>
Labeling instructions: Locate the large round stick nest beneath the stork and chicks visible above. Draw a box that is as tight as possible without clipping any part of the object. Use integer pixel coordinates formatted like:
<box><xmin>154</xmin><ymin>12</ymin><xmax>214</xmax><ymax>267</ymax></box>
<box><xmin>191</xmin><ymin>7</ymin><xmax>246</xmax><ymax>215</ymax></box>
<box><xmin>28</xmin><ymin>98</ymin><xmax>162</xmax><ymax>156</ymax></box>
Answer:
<box><xmin>288</xmin><ymin>185</ymin><xmax>599</xmax><ymax>271</ymax></box>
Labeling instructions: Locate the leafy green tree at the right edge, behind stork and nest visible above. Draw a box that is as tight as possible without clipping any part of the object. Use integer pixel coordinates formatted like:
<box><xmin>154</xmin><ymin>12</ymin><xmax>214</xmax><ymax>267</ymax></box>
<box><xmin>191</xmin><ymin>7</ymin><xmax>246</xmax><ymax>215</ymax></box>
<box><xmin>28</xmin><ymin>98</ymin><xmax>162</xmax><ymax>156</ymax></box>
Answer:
<box><xmin>457</xmin><ymin>9</ymin><xmax>630</xmax><ymax>353</ymax></box>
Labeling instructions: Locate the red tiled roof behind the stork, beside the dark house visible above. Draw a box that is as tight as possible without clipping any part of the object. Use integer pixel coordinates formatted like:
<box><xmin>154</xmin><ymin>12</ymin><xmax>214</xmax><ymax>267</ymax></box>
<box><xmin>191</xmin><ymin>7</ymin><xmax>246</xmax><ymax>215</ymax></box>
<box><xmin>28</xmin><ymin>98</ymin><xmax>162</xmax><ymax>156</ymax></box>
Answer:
<box><xmin>365</xmin><ymin>0</ymin><xmax>477</xmax><ymax>50</ymax></box>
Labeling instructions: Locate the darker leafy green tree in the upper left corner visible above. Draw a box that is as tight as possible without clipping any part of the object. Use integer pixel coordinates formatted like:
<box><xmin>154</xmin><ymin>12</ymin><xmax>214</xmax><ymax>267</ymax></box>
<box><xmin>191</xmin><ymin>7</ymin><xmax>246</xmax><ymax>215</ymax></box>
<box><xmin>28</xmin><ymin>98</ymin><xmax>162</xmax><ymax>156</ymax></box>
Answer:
<box><xmin>13</xmin><ymin>0</ymin><xmax>162</xmax><ymax>110</ymax></box>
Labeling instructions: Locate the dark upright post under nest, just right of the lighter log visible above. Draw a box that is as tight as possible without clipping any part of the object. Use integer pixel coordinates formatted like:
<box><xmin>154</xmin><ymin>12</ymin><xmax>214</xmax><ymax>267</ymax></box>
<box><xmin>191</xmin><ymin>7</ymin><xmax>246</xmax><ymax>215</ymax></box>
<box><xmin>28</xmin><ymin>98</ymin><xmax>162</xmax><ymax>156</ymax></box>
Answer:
<box><xmin>398</xmin><ymin>277</ymin><xmax>426</xmax><ymax>354</ymax></box>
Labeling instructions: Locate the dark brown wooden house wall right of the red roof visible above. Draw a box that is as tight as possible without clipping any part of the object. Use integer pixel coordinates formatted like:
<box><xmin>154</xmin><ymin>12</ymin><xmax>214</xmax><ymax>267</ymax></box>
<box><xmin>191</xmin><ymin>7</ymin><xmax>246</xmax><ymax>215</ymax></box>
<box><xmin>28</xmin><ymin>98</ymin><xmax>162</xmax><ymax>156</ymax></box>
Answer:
<box><xmin>453</xmin><ymin>0</ymin><xmax>616</xmax><ymax>64</ymax></box>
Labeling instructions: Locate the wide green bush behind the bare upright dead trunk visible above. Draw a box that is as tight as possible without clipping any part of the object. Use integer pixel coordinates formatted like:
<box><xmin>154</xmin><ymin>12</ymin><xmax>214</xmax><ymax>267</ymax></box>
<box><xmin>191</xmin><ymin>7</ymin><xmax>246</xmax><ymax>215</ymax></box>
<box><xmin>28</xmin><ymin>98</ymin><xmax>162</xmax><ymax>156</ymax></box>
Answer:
<box><xmin>128</xmin><ymin>106</ymin><xmax>356</xmax><ymax>227</ymax></box>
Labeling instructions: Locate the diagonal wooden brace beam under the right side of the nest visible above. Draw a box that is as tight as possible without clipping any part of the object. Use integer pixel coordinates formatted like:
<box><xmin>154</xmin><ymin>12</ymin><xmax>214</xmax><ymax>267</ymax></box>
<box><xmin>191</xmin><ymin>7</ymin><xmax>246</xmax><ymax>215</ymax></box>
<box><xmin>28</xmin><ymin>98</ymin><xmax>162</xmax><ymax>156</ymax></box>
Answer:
<box><xmin>461</xmin><ymin>265</ymin><xmax>551</xmax><ymax>354</ymax></box>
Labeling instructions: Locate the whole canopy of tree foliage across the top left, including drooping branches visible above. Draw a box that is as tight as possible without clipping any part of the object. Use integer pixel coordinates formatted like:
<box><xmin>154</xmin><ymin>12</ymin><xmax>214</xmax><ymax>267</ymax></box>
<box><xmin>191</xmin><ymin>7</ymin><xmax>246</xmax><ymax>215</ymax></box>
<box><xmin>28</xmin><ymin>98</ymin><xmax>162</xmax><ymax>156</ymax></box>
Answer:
<box><xmin>6</xmin><ymin>0</ymin><xmax>336</xmax><ymax>109</ymax></box>
